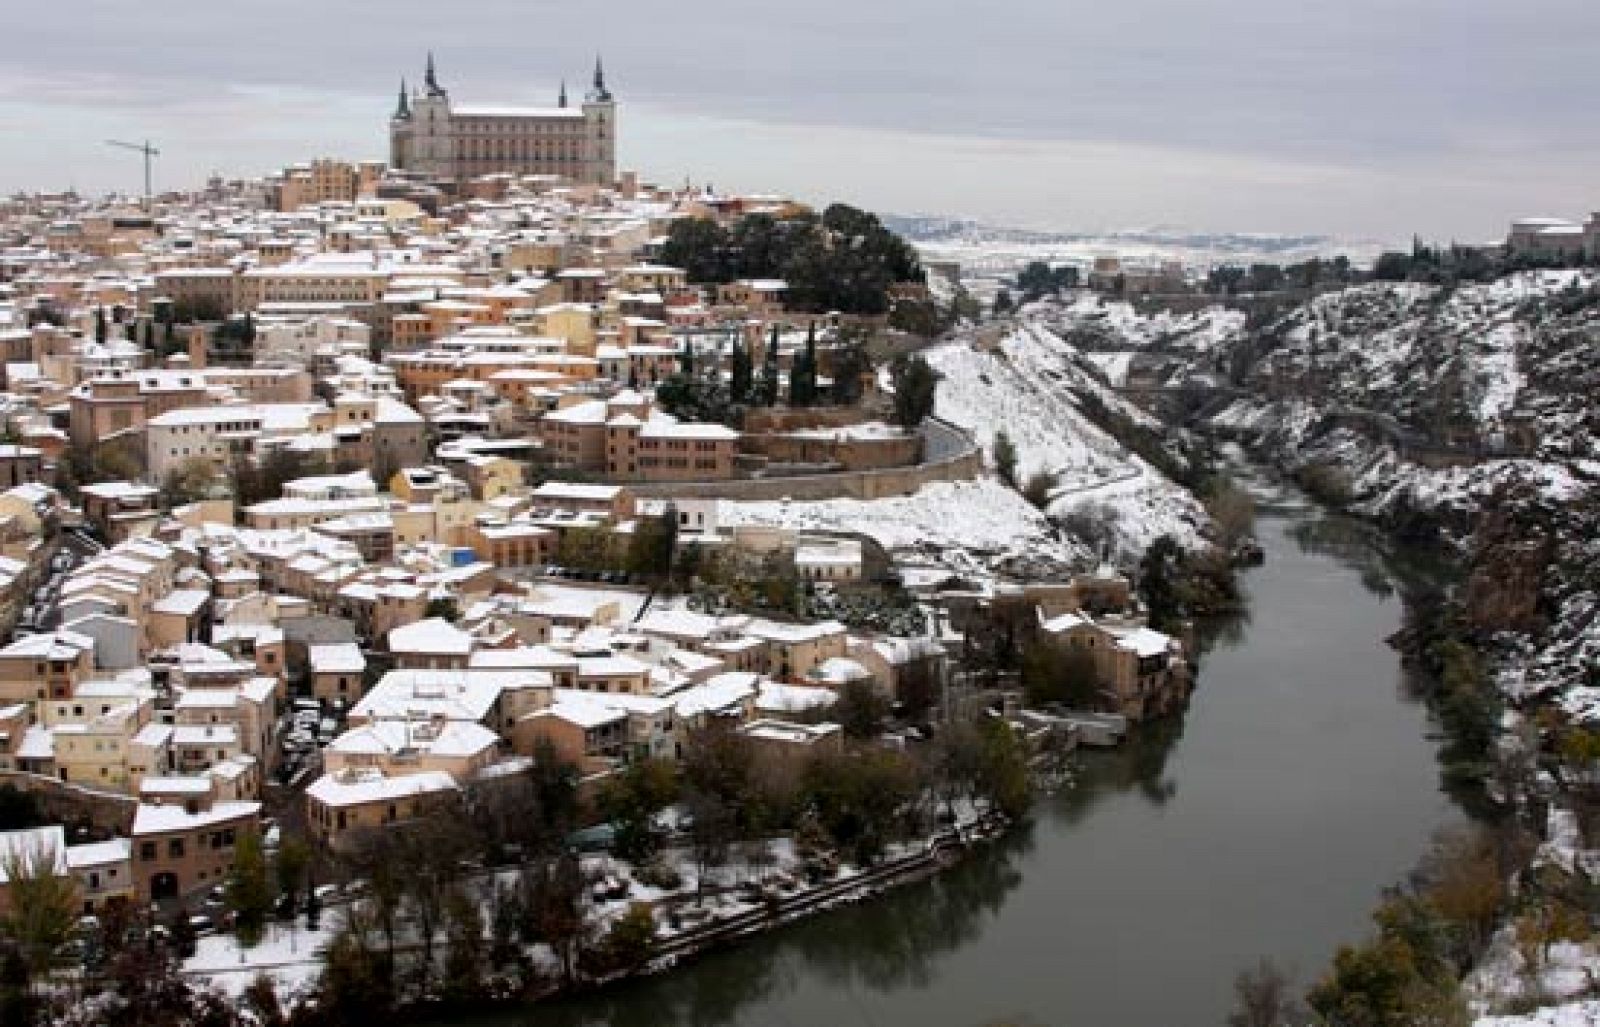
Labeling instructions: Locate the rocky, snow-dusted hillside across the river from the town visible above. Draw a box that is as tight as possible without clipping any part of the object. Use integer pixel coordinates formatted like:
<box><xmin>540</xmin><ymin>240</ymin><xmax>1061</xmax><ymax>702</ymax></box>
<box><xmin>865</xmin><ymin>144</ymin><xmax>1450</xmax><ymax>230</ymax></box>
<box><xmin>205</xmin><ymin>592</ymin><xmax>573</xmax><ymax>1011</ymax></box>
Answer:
<box><xmin>1213</xmin><ymin>270</ymin><xmax>1600</xmax><ymax>723</ymax></box>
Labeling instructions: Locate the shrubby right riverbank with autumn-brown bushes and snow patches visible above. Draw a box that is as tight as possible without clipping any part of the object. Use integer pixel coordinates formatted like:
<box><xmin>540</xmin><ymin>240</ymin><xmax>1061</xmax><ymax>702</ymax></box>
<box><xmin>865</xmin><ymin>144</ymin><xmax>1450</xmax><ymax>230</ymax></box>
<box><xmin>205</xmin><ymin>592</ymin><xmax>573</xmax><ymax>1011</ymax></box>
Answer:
<box><xmin>1209</xmin><ymin>444</ymin><xmax>1600</xmax><ymax>1025</ymax></box>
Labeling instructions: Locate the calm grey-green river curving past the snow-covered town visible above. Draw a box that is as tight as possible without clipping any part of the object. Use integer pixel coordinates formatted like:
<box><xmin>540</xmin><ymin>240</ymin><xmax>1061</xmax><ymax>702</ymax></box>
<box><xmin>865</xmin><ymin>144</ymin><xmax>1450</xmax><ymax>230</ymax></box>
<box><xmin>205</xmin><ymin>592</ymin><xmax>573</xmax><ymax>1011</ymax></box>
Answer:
<box><xmin>451</xmin><ymin>489</ymin><xmax>1462</xmax><ymax>1027</ymax></box>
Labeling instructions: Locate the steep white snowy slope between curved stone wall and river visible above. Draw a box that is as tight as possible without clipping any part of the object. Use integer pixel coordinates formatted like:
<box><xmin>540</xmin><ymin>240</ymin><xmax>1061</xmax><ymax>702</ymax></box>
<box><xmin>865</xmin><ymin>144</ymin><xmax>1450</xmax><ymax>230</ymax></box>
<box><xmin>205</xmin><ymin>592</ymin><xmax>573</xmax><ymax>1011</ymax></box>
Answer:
<box><xmin>926</xmin><ymin>325</ymin><xmax>1205</xmax><ymax>560</ymax></box>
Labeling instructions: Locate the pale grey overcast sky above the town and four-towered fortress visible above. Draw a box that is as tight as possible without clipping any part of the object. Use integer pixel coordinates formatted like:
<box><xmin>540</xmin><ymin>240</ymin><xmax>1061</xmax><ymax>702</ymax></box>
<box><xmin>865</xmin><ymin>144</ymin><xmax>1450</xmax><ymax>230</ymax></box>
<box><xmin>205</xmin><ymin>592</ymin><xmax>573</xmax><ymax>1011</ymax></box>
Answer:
<box><xmin>0</xmin><ymin>0</ymin><xmax>1600</xmax><ymax>240</ymax></box>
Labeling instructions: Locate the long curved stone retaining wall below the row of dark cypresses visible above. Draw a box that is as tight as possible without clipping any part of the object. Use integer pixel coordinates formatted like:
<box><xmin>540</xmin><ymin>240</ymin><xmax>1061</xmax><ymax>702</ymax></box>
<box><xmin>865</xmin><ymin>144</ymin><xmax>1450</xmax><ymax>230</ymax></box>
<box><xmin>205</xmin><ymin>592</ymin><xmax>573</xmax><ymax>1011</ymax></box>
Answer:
<box><xmin>634</xmin><ymin>418</ymin><xmax>984</xmax><ymax>501</ymax></box>
